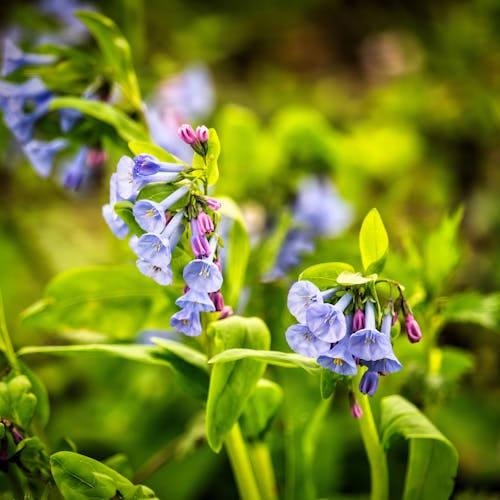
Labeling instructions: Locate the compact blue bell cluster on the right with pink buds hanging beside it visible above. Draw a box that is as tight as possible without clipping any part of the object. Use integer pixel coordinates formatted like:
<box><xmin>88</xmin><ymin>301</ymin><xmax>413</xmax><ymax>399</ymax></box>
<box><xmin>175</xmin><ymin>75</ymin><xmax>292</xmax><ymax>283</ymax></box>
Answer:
<box><xmin>286</xmin><ymin>280</ymin><xmax>422</xmax><ymax>411</ymax></box>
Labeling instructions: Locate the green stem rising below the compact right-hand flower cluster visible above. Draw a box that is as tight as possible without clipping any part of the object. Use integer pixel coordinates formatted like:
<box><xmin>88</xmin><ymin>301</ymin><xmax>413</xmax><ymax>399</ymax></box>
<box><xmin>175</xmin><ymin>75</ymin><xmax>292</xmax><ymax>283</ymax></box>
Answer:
<box><xmin>356</xmin><ymin>375</ymin><xmax>389</xmax><ymax>500</ymax></box>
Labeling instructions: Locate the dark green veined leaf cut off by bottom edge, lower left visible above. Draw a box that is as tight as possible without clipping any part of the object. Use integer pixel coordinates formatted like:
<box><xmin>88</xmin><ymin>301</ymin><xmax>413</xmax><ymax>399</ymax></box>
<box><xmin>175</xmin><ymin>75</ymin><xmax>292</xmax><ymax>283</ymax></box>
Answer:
<box><xmin>50</xmin><ymin>451</ymin><xmax>156</xmax><ymax>500</ymax></box>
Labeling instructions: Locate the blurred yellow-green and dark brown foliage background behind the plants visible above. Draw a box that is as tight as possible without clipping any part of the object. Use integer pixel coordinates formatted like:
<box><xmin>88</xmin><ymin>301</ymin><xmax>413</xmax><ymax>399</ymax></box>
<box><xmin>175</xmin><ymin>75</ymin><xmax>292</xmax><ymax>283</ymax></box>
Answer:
<box><xmin>0</xmin><ymin>0</ymin><xmax>500</xmax><ymax>499</ymax></box>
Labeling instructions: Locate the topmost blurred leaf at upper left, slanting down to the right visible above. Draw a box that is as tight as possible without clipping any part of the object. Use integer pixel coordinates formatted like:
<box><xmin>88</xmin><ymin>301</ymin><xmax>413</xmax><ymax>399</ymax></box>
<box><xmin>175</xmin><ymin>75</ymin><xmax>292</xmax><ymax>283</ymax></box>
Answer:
<box><xmin>75</xmin><ymin>11</ymin><xmax>142</xmax><ymax>110</ymax></box>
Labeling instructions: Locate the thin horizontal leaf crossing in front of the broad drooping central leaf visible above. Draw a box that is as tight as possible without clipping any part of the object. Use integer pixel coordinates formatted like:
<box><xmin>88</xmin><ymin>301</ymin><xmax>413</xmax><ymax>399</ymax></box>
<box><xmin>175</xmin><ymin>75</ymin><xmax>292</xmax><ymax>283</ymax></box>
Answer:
<box><xmin>208</xmin><ymin>348</ymin><xmax>320</xmax><ymax>373</ymax></box>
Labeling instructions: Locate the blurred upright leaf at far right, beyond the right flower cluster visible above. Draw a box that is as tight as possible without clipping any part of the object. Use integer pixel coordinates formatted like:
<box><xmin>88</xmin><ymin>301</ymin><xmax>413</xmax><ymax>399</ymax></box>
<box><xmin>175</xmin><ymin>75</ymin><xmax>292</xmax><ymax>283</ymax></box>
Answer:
<box><xmin>423</xmin><ymin>208</ymin><xmax>463</xmax><ymax>296</ymax></box>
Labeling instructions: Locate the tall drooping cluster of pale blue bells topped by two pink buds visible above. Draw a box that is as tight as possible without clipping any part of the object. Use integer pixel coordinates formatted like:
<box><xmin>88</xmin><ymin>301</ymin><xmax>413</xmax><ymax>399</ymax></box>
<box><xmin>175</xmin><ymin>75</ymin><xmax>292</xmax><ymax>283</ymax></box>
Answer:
<box><xmin>103</xmin><ymin>125</ymin><xmax>232</xmax><ymax>336</ymax></box>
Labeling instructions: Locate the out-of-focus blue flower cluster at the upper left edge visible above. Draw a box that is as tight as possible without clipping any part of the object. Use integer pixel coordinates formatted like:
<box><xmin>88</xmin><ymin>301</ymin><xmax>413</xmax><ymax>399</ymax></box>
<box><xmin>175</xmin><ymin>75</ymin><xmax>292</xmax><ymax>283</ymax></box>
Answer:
<box><xmin>0</xmin><ymin>40</ymin><xmax>106</xmax><ymax>190</ymax></box>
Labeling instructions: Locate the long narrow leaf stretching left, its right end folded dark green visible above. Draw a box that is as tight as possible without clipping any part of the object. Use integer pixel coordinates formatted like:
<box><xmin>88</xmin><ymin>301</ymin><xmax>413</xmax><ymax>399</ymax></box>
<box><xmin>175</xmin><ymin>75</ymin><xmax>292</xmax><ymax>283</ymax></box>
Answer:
<box><xmin>18</xmin><ymin>339</ymin><xmax>208</xmax><ymax>400</ymax></box>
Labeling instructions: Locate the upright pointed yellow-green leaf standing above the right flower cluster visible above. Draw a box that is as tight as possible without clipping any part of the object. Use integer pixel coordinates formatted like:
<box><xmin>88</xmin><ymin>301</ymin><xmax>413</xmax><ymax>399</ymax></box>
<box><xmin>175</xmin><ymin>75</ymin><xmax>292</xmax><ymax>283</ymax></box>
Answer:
<box><xmin>359</xmin><ymin>208</ymin><xmax>389</xmax><ymax>274</ymax></box>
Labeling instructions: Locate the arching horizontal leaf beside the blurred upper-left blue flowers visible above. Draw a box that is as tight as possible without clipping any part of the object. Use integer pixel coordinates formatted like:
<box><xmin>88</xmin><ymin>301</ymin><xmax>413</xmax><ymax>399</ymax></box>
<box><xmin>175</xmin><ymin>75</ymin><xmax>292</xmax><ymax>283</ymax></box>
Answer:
<box><xmin>50</xmin><ymin>97</ymin><xmax>149</xmax><ymax>142</ymax></box>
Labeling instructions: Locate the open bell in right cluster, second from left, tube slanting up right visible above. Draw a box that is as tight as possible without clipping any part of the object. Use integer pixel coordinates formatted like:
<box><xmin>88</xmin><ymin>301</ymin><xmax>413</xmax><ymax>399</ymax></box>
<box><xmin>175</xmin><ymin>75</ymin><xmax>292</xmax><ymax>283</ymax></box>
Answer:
<box><xmin>306</xmin><ymin>293</ymin><xmax>352</xmax><ymax>342</ymax></box>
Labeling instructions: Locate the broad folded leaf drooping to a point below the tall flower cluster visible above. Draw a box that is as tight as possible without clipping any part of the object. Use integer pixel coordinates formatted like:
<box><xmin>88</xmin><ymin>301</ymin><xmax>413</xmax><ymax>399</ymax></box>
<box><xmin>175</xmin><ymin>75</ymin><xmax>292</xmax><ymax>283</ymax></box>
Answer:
<box><xmin>206</xmin><ymin>316</ymin><xmax>271</xmax><ymax>452</ymax></box>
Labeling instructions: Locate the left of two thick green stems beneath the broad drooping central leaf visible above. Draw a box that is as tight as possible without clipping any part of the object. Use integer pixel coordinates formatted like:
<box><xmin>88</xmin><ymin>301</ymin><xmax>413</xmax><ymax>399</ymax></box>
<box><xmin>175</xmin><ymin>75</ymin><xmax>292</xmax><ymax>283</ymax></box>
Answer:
<box><xmin>224</xmin><ymin>423</ymin><xmax>261</xmax><ymax>500</ymax></box>
